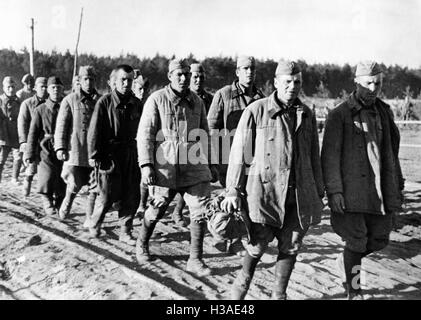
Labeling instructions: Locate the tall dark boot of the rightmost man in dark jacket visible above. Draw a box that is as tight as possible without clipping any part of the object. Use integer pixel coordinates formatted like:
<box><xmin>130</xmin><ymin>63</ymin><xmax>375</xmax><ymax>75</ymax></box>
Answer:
<box><xmin>344</xmin><ymin>248</ymin><xmax>363</xmax><ymax>300</ymax></box>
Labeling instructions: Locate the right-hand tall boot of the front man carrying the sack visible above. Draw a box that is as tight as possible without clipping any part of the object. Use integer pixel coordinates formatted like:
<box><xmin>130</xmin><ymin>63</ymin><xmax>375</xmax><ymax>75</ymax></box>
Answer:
<box><xmin>272</xmin><ymin>253</ymin><xmax>297</xmax><ymax>300</ymax></box>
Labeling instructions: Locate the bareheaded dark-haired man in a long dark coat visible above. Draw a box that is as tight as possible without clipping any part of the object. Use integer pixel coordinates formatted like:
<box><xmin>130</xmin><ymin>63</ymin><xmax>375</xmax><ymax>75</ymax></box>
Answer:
<box><xmin>87</xmin><ymin>65</ymin><xmax>141</xmax><ymax>245</ymax></box>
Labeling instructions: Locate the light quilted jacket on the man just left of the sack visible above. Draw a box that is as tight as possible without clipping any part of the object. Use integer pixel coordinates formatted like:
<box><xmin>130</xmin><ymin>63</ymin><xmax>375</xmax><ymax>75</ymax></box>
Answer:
<box><xmin>136</xmin><ymin>85</ymin><xmax>211</xmax><ymax>189</ymax></box>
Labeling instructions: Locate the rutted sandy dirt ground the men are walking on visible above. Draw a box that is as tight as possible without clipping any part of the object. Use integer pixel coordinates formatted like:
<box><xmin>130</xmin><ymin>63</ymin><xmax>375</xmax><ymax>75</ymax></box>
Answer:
<box><xmin>0</xmin><ymin>134</ymin><xmax>421</xmax><ymax>300</ymax></box>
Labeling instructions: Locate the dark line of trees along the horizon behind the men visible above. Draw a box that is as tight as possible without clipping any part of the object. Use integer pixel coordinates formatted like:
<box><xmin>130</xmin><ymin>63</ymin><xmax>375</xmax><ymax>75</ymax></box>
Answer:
<box><xmin>0</xmin><ymin>49</ymin><xmax>421</xmax><ymax>99</ymax></box>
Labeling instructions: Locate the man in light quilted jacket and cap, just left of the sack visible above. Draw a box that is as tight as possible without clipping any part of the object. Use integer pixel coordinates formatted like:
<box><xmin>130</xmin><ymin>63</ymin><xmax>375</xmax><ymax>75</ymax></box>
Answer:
<box><xmin>136</xmin><ymin>59</ymin><xmax>211</xmax><ymax>276</ymax></box>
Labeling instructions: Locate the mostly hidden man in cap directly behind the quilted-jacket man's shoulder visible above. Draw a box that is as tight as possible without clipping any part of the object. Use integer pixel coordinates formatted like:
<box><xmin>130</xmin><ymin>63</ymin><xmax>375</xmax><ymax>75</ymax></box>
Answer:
<box><xmin>172</xmin><ymin>63</ymin><xmax>213</xmax><ymax>227</ymax></box>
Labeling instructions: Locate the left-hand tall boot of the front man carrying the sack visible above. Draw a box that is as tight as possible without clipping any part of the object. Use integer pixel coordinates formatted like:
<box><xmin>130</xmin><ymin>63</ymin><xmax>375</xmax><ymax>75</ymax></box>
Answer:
<box><xmin>231</xmin><ymin>251</ymin><xmax>260</xmax><ymax>300</ymax></box>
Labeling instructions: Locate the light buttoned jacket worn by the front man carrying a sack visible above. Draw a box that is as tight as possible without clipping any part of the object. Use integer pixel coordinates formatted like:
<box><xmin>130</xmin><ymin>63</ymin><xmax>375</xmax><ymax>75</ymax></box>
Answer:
<box><xmin>226</xmin><ymin>91</ymin><xmax>324</xmax><ymax>229</ymax></box>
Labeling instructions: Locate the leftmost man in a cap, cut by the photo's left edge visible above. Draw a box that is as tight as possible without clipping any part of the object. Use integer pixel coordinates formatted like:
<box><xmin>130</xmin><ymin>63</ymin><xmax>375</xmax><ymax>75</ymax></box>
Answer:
<box><xmin>0</xmin><ymin>77</ymin><xmax>22</xmax><ymax>184</ymax></box>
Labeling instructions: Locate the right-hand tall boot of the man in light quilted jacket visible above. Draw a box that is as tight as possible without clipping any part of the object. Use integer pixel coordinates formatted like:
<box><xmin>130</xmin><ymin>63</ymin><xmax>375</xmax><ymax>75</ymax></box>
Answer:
<box><xmin>186</xmin><ymin>220</ymin><xmax>211</xmax><ymax>277</ymax></box>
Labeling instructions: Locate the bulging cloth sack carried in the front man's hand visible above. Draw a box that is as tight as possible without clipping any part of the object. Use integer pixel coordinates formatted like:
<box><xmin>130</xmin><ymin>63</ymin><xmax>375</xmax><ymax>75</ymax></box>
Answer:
<box><xmin>206</xmin><ymin>195</ymin><xmax>251</xmax><ymax>242</ymax></box>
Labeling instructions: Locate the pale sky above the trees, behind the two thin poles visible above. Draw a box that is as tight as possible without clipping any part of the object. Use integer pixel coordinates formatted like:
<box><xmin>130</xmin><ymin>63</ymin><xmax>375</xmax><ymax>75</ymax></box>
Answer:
<box><xmin>0</xmin><ymin>0</ymin><xmax>421</xmax><ymax>68</ymax></box>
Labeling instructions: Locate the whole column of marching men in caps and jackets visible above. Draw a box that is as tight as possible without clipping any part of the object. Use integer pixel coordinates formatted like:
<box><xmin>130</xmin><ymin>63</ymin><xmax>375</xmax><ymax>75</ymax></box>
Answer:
<box><xmin>0</xmin><ymin>56</ymin><xmax>404</xmax><ymax>300</ymax></box>
